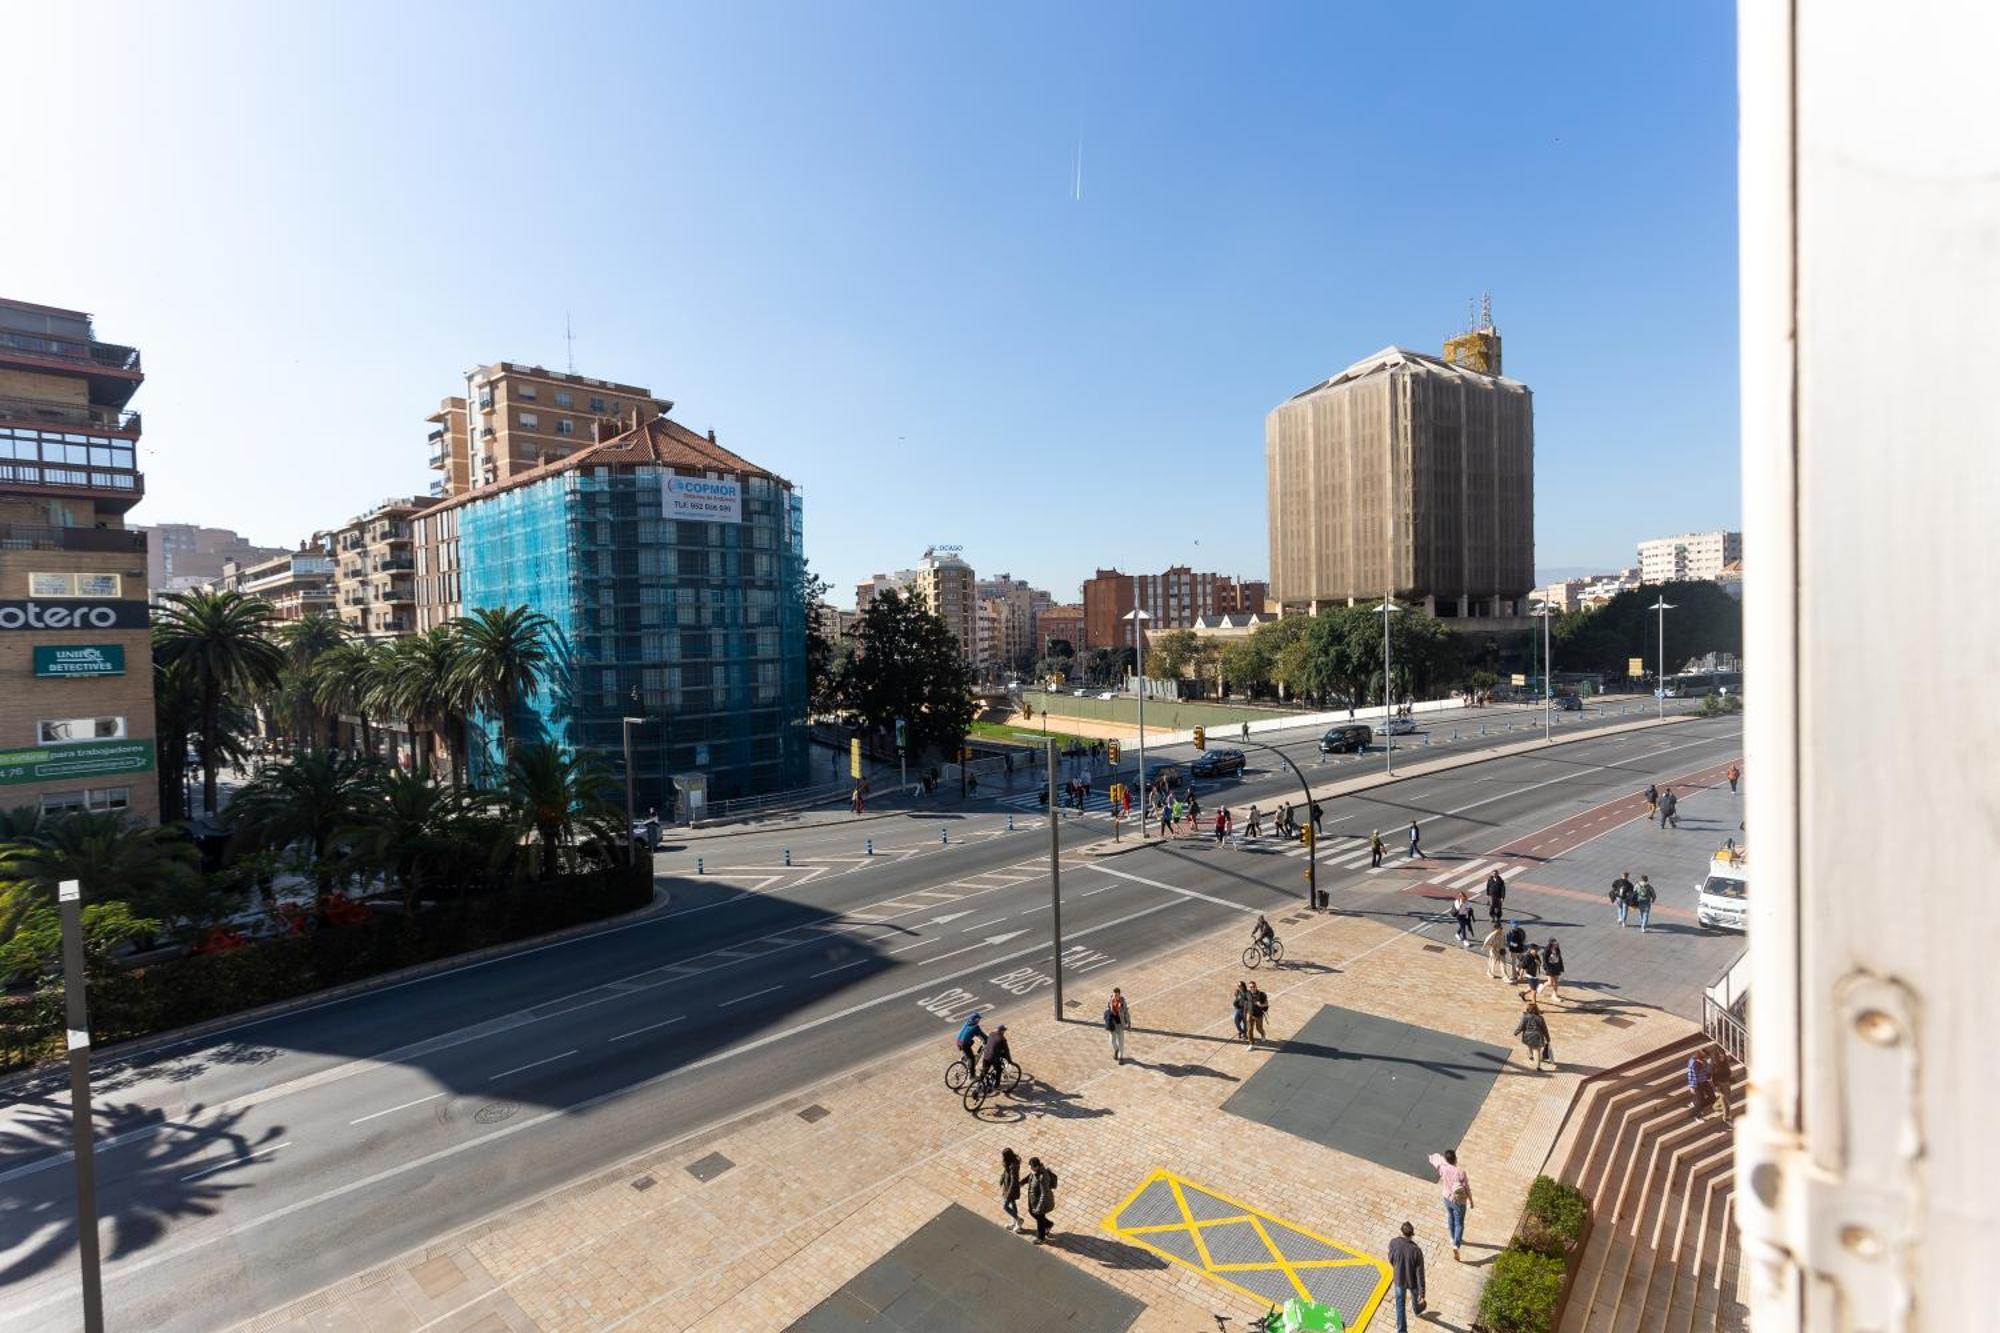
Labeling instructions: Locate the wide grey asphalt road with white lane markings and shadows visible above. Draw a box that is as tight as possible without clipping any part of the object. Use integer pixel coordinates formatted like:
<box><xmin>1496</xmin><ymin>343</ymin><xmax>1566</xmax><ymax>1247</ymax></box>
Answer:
<box><xmin>0</xmin><ymin>700</ymin><xmax>1740</xmax><ymax>1331</ymax></box>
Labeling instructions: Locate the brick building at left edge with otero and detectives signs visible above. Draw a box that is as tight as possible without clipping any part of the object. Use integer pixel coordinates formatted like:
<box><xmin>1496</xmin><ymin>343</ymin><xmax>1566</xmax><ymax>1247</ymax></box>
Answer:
<box><xmin>0</xmin><ymin>300</ymin><xmax>160</xmax><ymax>823</ymax></box>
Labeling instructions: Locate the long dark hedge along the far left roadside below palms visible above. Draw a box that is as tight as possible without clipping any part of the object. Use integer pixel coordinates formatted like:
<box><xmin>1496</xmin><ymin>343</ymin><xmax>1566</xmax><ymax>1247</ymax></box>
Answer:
<box><xmin>0</xmin><ymin>867</ymin><xmax>652</xmax><ymax>1069</ymax></box>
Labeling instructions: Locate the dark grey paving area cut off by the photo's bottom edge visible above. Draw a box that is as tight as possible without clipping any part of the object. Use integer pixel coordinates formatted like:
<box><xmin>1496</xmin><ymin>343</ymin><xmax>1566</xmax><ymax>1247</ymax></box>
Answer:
<box><xmin>790</xmin><ymin>1205</ymin><xmax>1144</xmax><ymax>1333</ymax></box>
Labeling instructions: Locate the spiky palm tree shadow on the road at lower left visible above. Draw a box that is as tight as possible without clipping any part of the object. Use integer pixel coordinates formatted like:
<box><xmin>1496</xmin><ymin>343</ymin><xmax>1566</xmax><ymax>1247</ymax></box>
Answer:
<box><xmin>0</xmin><ymin>1097</ymin><xmax>284</xmax><ymax>1287</ymax></box>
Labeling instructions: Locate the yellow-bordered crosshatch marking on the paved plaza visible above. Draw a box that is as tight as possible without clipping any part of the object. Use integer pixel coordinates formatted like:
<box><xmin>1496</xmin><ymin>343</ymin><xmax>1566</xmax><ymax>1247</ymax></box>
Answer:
<box><xmin>1104</xmin><ymin>1169</ymin><xmax>1390</xmax><ymax>1329</ymax></box>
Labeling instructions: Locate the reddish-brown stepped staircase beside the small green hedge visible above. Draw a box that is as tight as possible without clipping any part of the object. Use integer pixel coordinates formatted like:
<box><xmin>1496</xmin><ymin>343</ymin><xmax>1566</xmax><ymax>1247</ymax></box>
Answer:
<box><xmin>1550</xmin><ymin>1033</ymin><xmax>1748</xmax><ymax>1333</ymax></box>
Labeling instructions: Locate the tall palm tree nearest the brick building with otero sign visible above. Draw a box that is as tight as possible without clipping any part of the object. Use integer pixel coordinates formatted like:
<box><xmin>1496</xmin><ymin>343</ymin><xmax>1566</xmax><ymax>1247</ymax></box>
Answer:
<box><xmin>152</xmin><ymin>590</ymin><xmax>284</xmax><ymax>815</ymax></box>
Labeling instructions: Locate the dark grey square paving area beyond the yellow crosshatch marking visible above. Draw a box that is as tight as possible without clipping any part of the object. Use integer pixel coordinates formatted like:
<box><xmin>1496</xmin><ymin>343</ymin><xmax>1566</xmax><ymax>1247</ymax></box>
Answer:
<box><xmin>1222</xmin><ymin>1005</ymin><xmax>1506</xmax><ymax>1179</ymax></box>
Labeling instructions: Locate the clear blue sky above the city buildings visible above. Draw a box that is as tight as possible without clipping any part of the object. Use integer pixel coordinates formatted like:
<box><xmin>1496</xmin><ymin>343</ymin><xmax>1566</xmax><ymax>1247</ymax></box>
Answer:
<box><xmin>0</xmin><ymin>0</ymin><xmax>1738</xmax><ymax>600</ymax></box>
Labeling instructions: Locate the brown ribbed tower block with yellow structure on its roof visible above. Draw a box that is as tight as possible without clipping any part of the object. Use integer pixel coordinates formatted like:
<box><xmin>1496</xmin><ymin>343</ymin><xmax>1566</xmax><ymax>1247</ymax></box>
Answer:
<box><xmin>1264</xmin><ymin>322</ymin><xmax>1534</xmax><ymax>618</ymax></box>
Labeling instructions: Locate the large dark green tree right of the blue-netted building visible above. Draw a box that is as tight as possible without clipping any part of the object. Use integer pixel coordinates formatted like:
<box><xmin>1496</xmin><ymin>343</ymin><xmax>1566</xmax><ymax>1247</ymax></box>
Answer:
<box><xmin>846</xmin><ymin>592</ymin><xmax>976</xmax><ymax>757</ymax></box>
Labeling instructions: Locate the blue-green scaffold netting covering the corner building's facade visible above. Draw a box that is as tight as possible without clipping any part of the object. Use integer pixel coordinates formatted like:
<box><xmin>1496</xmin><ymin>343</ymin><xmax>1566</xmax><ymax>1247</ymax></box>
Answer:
<box><xmin>458</xmin><ymin>464</ymin><xmax>808</xmax><ymax>817</ymax></box>
